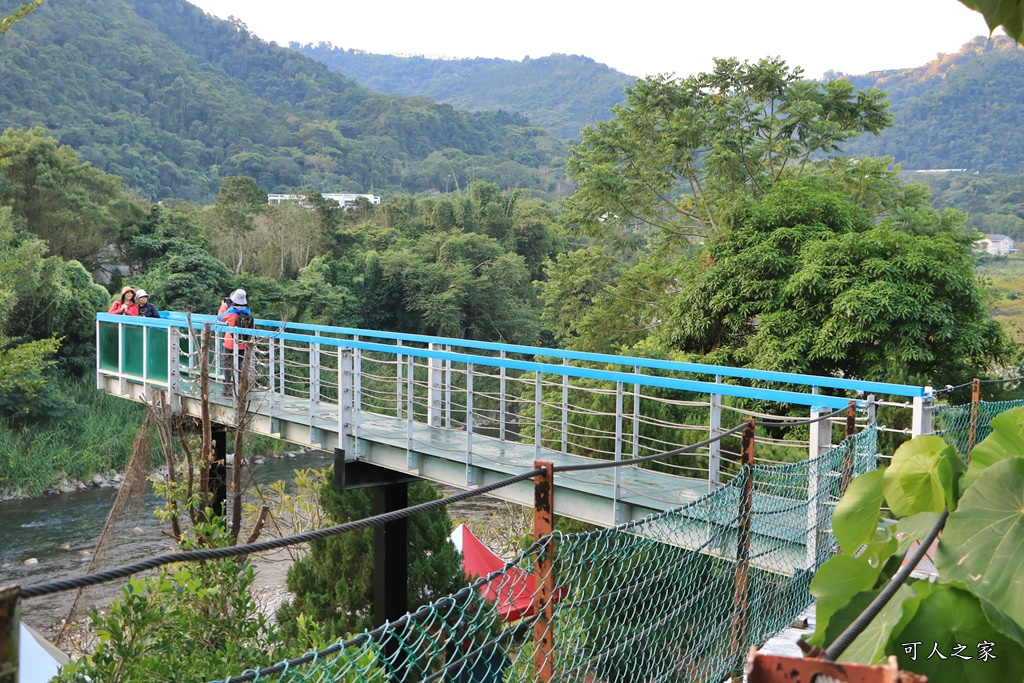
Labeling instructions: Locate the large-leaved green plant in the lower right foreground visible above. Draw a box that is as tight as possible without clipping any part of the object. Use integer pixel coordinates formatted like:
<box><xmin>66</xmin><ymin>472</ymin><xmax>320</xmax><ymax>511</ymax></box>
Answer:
<box><xmin>810</xmin><ymin>408</ymin><xmax>1024</xmax><ymax>683</ymax></box>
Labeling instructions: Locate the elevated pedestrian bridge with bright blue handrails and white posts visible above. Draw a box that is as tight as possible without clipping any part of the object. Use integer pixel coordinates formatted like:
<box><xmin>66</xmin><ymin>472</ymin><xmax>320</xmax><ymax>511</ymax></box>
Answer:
<box><xmin>96</xmin><ymin>312</ymin><xmax>932</xmax><ymax>573</ymax></box>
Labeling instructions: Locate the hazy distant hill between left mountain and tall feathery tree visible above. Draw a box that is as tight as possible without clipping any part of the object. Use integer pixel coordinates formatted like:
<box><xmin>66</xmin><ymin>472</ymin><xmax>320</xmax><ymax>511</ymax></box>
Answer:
<box><xmin>291</xmin><ymin>43</ymin><xmax>636</xmax><ymax>139</ymax></box>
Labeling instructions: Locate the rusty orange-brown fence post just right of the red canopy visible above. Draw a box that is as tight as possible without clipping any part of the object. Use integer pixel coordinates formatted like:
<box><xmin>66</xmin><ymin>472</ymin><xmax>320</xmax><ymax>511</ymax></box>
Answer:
<box><xmin>534</xmin><ymin>461</ymin><xmax>555</xmax><ymax>683</ymax></box>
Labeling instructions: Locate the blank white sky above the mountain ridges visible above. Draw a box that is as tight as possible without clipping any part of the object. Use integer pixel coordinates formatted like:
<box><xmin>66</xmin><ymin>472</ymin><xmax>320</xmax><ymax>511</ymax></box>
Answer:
<box><xmin>190</xmin><ymin>0</ymin><xmax>988</xmax><ymax>78</ymax></box>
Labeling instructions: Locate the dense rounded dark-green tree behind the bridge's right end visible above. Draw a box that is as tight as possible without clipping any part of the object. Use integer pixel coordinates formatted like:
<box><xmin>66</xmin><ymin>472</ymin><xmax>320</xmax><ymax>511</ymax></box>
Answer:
<box><xmin>651</xmin><ymin>178</ymin><xmax>1010</xmax><ymax>384</ymax></box>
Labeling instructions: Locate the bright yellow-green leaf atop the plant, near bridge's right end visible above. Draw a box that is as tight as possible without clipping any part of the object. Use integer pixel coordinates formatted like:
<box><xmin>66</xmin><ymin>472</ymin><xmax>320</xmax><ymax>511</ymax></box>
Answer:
<box><xmin>882</xmin><ymin>436</ymin><xmax>964</xmax><ymax>517</ymax></box>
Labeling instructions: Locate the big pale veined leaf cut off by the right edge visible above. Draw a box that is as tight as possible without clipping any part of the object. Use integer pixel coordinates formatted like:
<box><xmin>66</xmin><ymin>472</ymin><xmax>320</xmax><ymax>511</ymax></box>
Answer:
<box><xmin>935</xmin><ymin>458</ymin><xmax>1024</xmax><ymax>643</ymax></box>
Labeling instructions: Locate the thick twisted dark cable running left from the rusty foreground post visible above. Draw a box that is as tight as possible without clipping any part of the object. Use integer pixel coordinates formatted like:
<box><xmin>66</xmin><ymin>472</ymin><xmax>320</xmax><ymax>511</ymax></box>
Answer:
<box><xmin>22</xmin><ymin>469</ymin><xmax>544</xmax><ymax>598</ymax></box>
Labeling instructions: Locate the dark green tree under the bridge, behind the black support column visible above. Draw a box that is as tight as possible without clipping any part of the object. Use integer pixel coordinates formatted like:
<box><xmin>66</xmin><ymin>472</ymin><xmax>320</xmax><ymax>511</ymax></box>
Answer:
<box><xmin>278</xmin><ymin>477</ymin><xmax>465</xmax><ymax>639</ymax></box>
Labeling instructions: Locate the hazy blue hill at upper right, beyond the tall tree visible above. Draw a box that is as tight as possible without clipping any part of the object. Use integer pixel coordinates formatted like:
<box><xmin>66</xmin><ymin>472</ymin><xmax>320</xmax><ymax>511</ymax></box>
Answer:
<box><xmin>826</xmin><ymin>36</ymin><xmax>1024</xmax><ymax>173</ymax></box>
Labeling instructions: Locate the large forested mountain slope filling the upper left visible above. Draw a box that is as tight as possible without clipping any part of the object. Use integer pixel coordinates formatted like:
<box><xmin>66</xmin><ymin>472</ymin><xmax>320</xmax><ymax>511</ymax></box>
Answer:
<box><xmin>0</xmin><ymin>0</ymin><xmax>564</xmax><ymax>201</ymax></box>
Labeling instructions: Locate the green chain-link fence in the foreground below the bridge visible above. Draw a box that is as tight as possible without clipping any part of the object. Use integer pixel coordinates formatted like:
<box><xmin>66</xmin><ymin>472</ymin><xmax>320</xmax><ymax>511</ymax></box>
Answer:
<box><xmin>211</xmin><ymin>425</ymin><xmax>877</xmax><ymax>683</ymax></box>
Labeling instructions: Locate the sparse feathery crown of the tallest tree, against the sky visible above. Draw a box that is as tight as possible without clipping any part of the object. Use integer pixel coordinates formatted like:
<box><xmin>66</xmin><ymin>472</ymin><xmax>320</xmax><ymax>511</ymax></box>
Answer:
<box><xmin>566</xmin><ymin>59</ymin><xmax>891</xmax><ymax>238</ymax></box>
